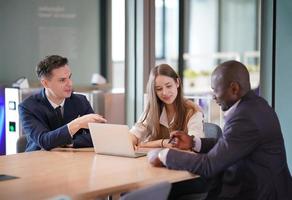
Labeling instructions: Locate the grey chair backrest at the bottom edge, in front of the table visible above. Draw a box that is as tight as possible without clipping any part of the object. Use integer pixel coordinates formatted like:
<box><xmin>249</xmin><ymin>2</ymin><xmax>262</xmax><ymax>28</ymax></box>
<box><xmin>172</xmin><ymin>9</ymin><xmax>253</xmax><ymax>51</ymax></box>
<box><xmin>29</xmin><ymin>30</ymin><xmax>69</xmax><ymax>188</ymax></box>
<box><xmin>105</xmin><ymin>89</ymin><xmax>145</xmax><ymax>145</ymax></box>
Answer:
<box><xmin>120</xmin><ymin>182</ymin><xmax>171</xmax><ymax>200</ymax></box>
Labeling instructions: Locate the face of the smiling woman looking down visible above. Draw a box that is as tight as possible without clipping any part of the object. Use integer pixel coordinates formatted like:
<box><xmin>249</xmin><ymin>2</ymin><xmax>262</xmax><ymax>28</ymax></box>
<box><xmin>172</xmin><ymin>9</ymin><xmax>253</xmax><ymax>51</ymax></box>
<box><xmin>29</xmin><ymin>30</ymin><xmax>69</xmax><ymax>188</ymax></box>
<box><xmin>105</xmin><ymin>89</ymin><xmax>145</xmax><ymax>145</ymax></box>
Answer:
<box><xmin>154</xmin><ymin>75</ymin><xmax>179</xmax><ymax>104</ymax></box>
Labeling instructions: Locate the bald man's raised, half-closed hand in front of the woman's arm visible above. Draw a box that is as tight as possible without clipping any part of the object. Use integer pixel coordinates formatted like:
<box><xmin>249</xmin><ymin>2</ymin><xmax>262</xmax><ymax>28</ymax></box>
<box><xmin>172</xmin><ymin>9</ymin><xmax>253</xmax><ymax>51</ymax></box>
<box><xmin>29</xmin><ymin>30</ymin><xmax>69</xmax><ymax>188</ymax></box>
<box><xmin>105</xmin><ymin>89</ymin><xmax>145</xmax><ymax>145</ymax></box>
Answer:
<box><xmin>170</xmin><ymin>131</ymin><xmax>193</xmax><ymax>150</ymax></box>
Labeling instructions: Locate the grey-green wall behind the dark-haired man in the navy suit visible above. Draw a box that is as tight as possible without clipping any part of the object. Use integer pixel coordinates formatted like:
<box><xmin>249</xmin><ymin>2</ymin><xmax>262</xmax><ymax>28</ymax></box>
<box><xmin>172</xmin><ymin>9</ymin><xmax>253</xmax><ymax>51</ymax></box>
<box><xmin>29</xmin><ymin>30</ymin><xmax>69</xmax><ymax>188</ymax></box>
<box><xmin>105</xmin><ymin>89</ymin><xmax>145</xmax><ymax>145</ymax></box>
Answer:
<box><xmin>0</xmin><ymin>0</ymin><xmax>100</xmax><ymax>85</ymax></box>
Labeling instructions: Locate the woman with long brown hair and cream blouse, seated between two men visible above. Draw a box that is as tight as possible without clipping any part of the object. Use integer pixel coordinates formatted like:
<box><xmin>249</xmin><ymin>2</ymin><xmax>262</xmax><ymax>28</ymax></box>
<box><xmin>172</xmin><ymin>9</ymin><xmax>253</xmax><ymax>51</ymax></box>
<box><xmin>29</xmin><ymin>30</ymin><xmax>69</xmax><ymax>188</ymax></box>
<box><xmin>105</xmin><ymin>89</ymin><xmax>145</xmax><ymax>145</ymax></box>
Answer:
<box><xmin>130</xmin><ymin>64</ymin><xmax>205</xmax><ymax>147</ymax></box>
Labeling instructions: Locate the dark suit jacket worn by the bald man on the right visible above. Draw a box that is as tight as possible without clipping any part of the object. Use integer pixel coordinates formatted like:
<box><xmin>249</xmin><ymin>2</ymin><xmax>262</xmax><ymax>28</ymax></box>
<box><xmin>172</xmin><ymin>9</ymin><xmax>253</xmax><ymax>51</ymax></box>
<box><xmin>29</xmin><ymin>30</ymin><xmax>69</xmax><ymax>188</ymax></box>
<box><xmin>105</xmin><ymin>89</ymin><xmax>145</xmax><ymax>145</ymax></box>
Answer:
<box><xmin>166</xmin><ymin>91</ymin><xmax>292</xmax><ymax>200</ymax></box>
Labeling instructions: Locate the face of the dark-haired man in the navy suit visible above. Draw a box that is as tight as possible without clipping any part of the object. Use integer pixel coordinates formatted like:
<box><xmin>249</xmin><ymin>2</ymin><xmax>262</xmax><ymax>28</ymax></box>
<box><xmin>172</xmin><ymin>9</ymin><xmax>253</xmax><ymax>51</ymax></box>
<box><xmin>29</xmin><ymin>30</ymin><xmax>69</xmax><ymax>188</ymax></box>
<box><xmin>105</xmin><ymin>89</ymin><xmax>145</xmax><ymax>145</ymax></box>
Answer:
<box><xmin>42</xmin><ymin>65</ymin><xmax>72</xmax><ymax>102</ymax></box>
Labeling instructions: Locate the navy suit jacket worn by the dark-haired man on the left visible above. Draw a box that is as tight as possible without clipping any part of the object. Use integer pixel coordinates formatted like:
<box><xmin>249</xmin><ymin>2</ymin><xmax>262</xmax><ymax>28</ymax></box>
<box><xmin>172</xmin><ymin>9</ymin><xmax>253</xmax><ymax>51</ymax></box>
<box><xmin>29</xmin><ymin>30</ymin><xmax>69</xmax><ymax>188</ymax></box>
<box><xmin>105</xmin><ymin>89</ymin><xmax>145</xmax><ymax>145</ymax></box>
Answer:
<box><xmin>19</xmin><ymin>89</ymin><xmax>93</xmax><ymax>151</ymax></box>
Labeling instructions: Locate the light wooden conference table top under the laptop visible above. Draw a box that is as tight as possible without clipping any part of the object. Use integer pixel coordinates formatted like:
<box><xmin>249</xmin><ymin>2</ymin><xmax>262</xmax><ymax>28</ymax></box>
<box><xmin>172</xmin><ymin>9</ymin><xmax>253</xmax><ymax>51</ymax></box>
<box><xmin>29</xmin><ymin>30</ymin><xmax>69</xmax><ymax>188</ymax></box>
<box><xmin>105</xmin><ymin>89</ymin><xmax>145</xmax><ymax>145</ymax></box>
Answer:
<box><xmin>0</xmin><ymin>148</ymin><xmax>196</xmax><ymax>200</ymax></box>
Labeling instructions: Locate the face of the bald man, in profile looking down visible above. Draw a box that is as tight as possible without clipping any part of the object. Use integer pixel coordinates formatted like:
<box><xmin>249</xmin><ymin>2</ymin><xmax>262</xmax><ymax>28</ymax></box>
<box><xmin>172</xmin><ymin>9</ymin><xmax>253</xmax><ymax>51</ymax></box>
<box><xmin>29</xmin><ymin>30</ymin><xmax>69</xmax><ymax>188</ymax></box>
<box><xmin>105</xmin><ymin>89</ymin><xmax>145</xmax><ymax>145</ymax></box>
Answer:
<box><xmin>211</xmin><ymin>74</ymin><xmax>238</xmax><ymax>111</ymax></box>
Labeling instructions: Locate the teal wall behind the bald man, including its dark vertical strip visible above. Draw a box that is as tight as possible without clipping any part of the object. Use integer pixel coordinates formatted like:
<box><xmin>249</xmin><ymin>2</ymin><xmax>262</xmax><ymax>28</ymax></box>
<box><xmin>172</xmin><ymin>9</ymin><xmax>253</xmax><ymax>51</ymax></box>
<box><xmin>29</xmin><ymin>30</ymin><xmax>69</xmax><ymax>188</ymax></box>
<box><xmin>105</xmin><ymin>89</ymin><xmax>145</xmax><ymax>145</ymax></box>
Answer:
<box><xmin>260</xmin><ymin>0</ymin><xmax>292</xmax><ymax>172</ymax></box>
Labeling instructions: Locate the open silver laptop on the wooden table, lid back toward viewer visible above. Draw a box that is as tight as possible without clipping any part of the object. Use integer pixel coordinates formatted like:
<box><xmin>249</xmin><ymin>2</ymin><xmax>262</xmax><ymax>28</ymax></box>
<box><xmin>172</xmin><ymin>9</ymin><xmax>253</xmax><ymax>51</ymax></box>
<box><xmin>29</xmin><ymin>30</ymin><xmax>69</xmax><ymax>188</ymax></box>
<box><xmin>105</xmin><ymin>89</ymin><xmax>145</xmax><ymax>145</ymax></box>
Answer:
<box><xmin>88</xmin><ymin>123</ymin><xmax>146</xmax><ymax>158</ymax></box>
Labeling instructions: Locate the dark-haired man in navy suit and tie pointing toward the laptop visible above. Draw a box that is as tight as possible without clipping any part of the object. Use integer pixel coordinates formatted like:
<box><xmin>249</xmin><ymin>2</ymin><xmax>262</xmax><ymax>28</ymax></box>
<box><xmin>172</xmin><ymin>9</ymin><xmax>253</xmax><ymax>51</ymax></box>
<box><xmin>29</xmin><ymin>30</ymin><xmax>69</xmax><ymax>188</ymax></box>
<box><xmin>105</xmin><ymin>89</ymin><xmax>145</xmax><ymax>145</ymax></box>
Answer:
<box><xmin>19</xmin><ymin>55</ymin><xmax>106</xmax><ymax>151</ymax></box>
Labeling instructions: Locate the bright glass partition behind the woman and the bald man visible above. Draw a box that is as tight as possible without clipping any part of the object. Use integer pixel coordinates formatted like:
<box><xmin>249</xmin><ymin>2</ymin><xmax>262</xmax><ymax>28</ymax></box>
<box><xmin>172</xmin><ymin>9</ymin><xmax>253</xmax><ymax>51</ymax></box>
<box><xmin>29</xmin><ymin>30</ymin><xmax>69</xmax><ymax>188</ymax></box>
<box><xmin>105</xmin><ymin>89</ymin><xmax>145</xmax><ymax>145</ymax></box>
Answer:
<box><xmin>155</xmin><ymin>0</ymin><xmax>261</xmax><ymax>125</ymax></box>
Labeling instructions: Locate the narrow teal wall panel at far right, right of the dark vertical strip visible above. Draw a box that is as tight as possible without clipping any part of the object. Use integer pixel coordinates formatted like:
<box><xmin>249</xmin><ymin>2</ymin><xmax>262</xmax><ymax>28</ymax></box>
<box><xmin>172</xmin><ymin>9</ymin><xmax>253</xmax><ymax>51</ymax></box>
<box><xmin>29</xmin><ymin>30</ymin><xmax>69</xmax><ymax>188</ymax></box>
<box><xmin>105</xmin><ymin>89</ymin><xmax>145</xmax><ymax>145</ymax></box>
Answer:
<box><xmin>275</xmin><ymin>0</ymin><xmax>292</xmax><ymax>172</ymax></box>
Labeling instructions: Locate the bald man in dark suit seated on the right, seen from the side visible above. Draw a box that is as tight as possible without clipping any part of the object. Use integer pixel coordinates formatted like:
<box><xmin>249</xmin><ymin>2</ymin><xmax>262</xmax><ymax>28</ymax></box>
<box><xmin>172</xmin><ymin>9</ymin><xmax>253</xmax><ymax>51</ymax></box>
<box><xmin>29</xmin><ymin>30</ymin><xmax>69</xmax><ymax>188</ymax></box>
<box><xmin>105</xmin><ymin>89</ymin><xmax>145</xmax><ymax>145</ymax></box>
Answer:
<box><xmin>151</xmin><ymin>61</ymin><xmax>292</xmax><ymax>200</ymax></box>
